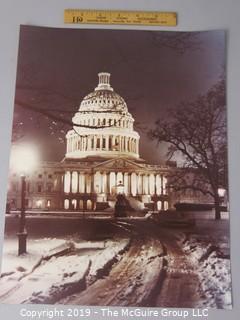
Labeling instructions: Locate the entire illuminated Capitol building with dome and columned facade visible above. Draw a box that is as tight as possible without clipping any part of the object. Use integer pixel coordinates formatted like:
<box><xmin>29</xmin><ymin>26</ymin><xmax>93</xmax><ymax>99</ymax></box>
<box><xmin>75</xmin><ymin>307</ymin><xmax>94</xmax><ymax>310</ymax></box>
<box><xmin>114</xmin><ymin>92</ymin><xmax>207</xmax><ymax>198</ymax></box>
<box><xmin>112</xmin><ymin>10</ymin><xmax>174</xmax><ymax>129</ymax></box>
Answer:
<box><xmin>8</xmin><ymin>72</ymin><xmax>206</xmax><ymax>211</ymax></box>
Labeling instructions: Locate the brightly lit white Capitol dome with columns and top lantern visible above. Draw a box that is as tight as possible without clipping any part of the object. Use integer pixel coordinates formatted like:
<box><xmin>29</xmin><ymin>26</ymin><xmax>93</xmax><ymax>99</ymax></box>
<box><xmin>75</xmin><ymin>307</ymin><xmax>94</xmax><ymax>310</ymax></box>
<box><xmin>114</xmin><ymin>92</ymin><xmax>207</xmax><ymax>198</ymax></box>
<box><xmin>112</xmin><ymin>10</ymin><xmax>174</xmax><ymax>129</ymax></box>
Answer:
<box><xmin>66</xmin><ymin>72</ymin><xmax>139</xmax><ymax>159</ymax></box>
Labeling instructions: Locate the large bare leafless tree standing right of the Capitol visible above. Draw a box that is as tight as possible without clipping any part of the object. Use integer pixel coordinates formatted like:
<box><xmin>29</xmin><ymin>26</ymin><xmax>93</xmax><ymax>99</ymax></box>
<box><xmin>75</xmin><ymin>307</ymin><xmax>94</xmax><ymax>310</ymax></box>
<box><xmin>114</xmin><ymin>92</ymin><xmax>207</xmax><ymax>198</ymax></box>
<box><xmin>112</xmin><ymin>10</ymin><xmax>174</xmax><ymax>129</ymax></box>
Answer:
<box><xmin>149</xmin><ymin>80</ymin><xmax>227</xmax><ymax>219</ymax></box>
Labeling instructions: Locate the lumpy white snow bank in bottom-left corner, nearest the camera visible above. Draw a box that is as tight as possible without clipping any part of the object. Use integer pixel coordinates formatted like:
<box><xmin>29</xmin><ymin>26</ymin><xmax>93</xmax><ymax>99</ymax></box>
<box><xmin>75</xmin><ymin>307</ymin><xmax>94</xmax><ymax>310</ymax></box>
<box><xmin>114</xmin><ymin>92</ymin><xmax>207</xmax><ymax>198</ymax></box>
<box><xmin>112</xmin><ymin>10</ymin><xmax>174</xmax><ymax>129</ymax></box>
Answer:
<box><xmin>1</xmin><ymin>255</ymin><xmax>90</xmax><ymax>304</ymax></box>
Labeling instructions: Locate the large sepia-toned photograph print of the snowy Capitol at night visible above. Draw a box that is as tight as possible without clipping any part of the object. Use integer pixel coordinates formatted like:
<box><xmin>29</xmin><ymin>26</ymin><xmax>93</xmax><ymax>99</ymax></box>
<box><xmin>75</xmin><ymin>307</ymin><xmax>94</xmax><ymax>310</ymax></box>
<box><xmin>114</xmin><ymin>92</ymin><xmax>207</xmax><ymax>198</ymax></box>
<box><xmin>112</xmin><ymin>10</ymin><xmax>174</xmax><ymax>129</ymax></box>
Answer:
<box><xmin>0</xmin><ymin>25</ymin><xmax>232</xmax><ymax>309</ymax></box>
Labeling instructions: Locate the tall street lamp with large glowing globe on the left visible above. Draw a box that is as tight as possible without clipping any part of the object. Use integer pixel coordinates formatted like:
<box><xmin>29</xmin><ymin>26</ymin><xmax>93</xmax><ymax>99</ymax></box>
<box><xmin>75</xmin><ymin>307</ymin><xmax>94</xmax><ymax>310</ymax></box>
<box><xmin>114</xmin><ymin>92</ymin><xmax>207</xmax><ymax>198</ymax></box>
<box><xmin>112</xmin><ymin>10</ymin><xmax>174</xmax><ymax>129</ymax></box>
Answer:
<box><xmin>10</xmin><ymin>144</ymin><xmax>38</xmax><ymax>255</ymax></box>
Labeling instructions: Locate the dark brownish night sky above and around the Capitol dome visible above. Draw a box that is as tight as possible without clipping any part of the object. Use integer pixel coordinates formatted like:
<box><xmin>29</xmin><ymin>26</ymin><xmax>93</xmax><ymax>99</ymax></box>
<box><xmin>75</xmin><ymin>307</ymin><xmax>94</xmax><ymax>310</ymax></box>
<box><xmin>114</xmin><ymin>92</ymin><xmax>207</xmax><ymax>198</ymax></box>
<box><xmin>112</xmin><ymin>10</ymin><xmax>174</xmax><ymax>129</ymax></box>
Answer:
<box><xmin>14</xmin><ymin>26</ymin><xmax>225</xmax><ymax>163</ymax></box>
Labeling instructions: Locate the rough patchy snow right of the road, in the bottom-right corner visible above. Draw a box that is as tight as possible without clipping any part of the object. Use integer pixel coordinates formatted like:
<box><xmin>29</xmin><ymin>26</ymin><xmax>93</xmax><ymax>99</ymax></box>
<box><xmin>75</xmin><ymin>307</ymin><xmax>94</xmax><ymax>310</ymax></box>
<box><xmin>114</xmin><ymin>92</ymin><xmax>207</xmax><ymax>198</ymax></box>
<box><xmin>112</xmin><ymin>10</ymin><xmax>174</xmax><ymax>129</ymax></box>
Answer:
<box><xmin>183</xmin><ymin>236</ymin><xmax>232</xmax><ymax>309</ymax></box>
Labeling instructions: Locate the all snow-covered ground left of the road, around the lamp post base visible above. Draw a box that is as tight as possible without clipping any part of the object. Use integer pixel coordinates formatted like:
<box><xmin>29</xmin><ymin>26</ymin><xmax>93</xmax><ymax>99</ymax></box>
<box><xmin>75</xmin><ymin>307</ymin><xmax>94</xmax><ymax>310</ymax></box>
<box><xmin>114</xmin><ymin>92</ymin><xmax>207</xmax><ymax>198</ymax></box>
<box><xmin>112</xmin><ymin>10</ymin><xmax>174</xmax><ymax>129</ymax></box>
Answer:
<box><xmin>0</xmin><ymin>238</ymin><xmax>129</xmax><ymax>304</ymax></box>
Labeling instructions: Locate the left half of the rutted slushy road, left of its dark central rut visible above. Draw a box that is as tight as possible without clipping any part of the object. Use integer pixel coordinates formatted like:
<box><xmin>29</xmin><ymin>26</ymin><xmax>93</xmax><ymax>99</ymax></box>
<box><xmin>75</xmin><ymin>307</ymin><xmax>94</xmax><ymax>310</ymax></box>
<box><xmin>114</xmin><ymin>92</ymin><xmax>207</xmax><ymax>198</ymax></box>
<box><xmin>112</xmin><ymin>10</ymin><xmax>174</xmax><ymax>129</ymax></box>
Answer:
<box><xmin>60</xmin><ymin>237</ymin><xmax>163</xmax><ymax>306</ymax></box>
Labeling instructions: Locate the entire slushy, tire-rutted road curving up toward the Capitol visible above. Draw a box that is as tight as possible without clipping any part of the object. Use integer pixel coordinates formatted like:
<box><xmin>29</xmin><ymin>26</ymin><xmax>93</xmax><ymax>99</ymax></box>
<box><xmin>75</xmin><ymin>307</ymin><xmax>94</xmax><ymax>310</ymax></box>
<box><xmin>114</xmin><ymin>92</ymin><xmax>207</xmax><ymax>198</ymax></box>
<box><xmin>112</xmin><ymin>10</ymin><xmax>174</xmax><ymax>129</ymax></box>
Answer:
<box><xmin>60</xmin><ymin>221</ymin><xmax>202</xmax><ymax>307</ymax></box>
